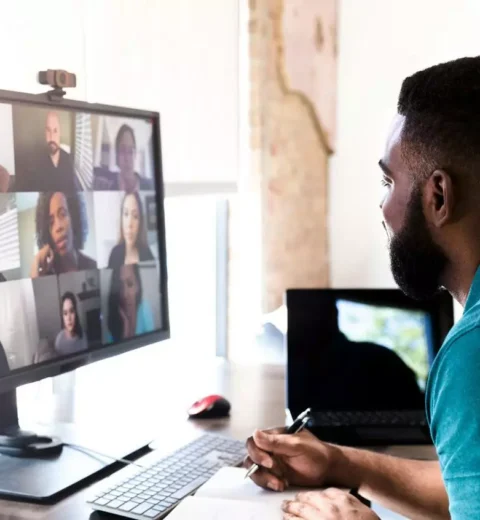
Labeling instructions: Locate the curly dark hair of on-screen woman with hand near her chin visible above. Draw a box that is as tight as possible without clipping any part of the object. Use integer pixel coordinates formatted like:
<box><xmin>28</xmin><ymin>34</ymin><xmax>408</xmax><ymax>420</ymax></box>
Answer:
<box><xmin>35</xmin><ymin>192</ymin><xmax>88</xmax><ymax>251</ymax></box>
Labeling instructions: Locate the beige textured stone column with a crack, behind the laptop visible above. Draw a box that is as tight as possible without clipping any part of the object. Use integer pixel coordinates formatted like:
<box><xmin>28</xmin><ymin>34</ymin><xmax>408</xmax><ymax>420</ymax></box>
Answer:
<box><xmin>249</xmin><ymin>0</ymin><xmax>336</xmax><ymax>312</ymax></box>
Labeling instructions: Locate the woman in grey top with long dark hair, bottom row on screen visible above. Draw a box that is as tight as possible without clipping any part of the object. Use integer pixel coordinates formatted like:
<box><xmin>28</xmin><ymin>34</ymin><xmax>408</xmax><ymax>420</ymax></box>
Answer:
<box><xmin>55</xmin><ymin>292</ymin><xmax>88</xmax><ymax>356</ymax></box>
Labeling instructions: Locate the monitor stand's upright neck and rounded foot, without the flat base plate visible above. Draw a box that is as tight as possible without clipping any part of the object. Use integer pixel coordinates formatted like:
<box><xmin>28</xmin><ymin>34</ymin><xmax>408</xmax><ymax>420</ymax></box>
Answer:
<box><xmin>0</xmin><ymin>389</ymin><xmax>63</xmax><ymax>457</ymax></box>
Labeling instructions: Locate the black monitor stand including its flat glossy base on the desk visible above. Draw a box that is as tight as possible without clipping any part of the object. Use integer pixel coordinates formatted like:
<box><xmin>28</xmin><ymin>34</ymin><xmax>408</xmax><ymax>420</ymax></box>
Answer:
<box><xmin>0</xmin><ymin>390</ymin><xmax>152</xmax><ymax>504</ymax></box>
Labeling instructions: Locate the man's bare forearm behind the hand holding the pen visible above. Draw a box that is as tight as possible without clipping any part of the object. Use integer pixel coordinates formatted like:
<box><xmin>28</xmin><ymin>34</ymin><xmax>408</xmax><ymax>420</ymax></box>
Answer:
<box><xmin>331</xmin><ymin>447</ymin><xmax>450</xmax><ymax>520</ymax></box>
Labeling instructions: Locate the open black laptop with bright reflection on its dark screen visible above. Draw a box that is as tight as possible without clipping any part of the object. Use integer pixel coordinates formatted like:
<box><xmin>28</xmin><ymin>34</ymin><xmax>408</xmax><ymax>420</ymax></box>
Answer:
<box><xmin>286</xmin><ymin>289</ymin><xmax>453</xmax><ymax>446</ymax></box>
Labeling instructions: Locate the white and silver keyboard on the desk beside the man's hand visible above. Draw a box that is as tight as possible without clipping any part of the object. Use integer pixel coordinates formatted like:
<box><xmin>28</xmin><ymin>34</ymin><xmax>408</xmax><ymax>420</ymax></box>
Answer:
<box><xmin>87</xmin><ymin>434</ymin><xmax>246</xmax><ymax>520</ymax></box>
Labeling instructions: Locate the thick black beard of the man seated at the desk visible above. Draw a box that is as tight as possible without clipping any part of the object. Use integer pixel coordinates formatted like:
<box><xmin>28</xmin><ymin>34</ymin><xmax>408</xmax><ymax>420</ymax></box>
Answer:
<box><xmin>389</xmin><ymin>189</ymin><xmax>447</xmax><ymax>300</ymax></box>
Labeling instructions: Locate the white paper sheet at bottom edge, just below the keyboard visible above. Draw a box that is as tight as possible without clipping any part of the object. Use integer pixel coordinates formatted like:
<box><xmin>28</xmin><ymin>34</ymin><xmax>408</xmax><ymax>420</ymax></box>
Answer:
<box><xmin>168</xmin><ymin>497</ymin><xmax>283</xmax><ymax>520</ymax></box>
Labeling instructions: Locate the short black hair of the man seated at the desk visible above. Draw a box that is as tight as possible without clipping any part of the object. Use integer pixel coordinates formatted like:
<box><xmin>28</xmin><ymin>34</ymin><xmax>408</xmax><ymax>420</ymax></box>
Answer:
<box><xmin>398</xmin><ymin>57</ymin><xmax>480</xmax><ymax>193</ymax></box>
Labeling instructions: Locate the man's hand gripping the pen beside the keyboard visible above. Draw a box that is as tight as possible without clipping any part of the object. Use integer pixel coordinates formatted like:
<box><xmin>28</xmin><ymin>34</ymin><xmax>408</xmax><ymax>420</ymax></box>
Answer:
<box><xmin>244</xmin><ymin>429</ymin><xmax>336</xmax><ymax>491</ymax></box>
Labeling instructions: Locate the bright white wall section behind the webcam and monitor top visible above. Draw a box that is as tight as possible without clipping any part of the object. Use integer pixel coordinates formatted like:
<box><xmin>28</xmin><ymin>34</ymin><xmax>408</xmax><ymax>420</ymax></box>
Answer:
<box><xmin>0</xmin><ymin>0</ymin><xmax>239</xmax><ymax>192</ymax></box>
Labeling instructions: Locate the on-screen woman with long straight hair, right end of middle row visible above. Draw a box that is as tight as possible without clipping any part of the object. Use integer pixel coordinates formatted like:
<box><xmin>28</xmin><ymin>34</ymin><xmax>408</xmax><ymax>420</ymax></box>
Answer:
<box><xmin>108</xmin><ymin>191</ymin><xmax>154</xmax><ymax>268</ymax></box>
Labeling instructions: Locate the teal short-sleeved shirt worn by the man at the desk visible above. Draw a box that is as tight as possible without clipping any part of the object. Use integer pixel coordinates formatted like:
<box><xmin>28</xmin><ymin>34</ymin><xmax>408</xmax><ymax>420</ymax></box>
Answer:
<box><xmin>426</xmin><ymin>268</ymin><xmax>480</xmax><ymax>520</ymax></box>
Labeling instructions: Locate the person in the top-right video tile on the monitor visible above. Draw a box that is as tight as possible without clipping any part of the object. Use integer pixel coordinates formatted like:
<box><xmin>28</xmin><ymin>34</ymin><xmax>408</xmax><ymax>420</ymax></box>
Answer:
<box><xmin>93</xmin><ymin>124</ymin><xmax>154</xmax><ymax>193</ymax></box>
